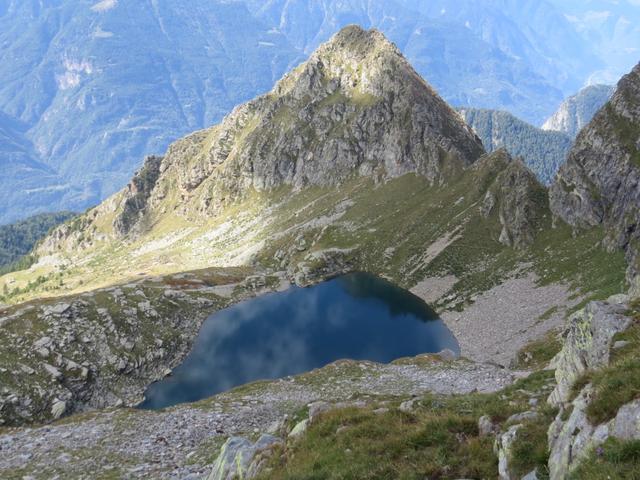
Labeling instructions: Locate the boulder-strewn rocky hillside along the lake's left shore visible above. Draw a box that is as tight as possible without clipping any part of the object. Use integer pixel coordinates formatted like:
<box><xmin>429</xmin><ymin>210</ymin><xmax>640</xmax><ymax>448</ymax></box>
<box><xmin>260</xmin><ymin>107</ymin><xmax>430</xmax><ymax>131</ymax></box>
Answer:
<box><xmin>0</xmin><ymin>269</ymin><xmax>270</xmax><ymax>426</ymax></box>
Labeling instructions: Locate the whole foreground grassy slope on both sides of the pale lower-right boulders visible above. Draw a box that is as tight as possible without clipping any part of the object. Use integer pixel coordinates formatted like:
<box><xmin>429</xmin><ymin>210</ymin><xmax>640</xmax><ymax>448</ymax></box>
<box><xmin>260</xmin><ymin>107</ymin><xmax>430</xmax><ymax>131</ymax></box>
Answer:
<box><xmin>262</xmin><ymin>303</ymin><xmax>640</xmax><ymax>480</ymax></box>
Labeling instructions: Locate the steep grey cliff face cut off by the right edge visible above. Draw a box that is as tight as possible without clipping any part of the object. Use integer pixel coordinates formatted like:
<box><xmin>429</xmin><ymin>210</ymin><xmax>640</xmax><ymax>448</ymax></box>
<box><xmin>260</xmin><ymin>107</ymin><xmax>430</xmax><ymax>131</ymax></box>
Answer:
<box><xmin>550</xmin><ymin>65</ymin><xmax>640</xmax><ymax>277</ymax></box>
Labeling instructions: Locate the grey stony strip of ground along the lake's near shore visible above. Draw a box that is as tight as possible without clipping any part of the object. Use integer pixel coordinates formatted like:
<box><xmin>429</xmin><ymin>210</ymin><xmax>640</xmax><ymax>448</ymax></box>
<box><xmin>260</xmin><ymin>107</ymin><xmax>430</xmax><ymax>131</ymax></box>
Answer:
<box><xmin>0</xmin><ymin>356</ymin><xmax>518</xmax><ymax>479</ymax></box>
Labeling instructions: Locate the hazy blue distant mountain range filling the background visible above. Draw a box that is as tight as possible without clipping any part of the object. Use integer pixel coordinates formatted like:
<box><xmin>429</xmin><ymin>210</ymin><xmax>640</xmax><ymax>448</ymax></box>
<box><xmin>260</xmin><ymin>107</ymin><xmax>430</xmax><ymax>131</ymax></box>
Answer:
<box><xmin>0</xmin><ymin>0</ymin><xmax>637</xmax><ymax>222</ymax></box>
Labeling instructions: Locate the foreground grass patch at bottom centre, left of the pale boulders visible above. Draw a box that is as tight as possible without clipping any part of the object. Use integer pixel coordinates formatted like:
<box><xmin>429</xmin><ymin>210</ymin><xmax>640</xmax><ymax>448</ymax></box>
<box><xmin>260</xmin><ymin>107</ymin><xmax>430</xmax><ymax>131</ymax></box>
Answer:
<box><xmin>262</xmin><ymin>372</ymin><xmax>553</xmax><ymax>480</ymax></box>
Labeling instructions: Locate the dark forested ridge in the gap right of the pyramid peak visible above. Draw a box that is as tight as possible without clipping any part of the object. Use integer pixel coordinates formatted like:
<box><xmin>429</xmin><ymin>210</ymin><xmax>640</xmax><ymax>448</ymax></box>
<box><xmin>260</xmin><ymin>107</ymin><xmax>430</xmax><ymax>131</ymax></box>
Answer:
<box><xmin>460</xmin><ymin>108</ymin><xmax>573</xmax><ymax>185</ymax></box>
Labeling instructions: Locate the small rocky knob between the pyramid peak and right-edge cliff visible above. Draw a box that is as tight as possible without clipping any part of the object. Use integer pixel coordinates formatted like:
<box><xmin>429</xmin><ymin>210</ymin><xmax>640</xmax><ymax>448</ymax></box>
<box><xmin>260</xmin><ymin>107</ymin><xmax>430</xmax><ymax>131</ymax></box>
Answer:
<box><xmin>474</xmin><ymin>150</ymin><xmax>548</xmax><ymax>248</ymax></box>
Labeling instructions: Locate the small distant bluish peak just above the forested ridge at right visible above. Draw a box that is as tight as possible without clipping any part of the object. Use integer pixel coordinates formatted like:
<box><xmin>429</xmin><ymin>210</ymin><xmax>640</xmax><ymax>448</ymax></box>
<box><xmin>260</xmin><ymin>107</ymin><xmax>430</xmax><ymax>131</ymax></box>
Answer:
<box><xmin>542</xmin><ymin>85</ymin><xmax>615</xmax><ymax>138</ymax></box>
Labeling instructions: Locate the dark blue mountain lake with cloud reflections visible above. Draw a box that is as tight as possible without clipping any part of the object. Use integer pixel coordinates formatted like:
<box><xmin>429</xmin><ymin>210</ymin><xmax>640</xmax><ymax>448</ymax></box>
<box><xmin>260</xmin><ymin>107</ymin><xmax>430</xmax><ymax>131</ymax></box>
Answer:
<box><xmin>140</xmin><ymin>273</ymin><xmax>459</xmax><ymax>409</ymax></box>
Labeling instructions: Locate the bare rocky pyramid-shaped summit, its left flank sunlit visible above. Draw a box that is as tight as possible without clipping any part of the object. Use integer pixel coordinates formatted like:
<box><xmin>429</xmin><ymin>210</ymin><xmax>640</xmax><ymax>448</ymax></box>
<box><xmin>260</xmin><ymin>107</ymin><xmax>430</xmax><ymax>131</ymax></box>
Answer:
<box><xmin>115</xmin><ymin>26</ymin><xmax>483</xmax><ymax>234</ymax></box>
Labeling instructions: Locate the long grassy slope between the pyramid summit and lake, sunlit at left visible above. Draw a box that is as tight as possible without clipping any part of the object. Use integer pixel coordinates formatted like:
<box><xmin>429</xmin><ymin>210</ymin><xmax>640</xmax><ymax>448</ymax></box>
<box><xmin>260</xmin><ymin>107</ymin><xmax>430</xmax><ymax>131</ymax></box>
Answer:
<box><xmin>0</xmin><ymin>153</ymin><xmax>624</xmax><ymax>308</ymax></box>
